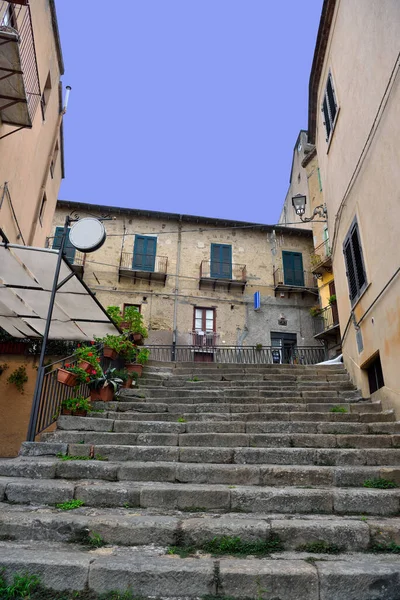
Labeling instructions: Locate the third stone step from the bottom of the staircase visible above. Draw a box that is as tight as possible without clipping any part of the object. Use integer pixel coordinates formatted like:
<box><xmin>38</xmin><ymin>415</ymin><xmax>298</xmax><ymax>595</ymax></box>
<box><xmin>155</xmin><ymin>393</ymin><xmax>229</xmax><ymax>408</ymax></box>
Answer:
<box><xmin>0</xmin><ymin>478</ymin><xmax>400</xmax><ymax>516</ymax></box>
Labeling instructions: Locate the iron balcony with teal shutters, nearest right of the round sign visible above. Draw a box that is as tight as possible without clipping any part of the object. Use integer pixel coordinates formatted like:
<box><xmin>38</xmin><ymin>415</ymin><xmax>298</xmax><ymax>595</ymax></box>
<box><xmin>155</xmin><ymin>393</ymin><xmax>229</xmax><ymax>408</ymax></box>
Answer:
<box><xmin>118</xmin><ymin>252</ymin><xmax>168</xmax><ymax>286</ymax></box>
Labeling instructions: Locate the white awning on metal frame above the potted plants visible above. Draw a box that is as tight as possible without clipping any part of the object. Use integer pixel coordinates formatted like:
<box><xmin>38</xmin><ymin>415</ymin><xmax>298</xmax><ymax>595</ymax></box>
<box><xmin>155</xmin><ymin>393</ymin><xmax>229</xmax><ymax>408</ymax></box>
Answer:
<box><xmin>0</xmin><ymin>244</ymin><xmax>119</xmax><ymax>340</ymax></box>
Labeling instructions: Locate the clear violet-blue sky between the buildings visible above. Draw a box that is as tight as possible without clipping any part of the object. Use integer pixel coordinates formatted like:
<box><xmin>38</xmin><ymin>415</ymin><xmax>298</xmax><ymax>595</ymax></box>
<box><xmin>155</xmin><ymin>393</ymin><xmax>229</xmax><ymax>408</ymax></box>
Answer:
<box><xmin>57</xmin><ymin>0</ymin><xmax>322</xmax><ymax>224</ymax></box>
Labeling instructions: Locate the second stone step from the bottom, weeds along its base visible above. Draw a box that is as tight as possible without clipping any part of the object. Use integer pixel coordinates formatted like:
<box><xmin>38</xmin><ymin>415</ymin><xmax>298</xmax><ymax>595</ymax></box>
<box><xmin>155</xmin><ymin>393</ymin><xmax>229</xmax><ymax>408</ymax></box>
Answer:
<box><xmin>0</xmin><ymin>505</ymin><xmax>400</xmax><ymax>552</ymax></box>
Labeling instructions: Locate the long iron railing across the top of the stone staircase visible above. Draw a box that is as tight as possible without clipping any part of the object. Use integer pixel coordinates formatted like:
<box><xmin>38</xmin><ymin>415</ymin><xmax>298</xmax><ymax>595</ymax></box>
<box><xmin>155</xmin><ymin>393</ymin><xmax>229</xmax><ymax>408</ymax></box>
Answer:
<box><xmin>146</xmin><ymin>345</ymin><xmax>326</xmax><ymax>365</ymax></box>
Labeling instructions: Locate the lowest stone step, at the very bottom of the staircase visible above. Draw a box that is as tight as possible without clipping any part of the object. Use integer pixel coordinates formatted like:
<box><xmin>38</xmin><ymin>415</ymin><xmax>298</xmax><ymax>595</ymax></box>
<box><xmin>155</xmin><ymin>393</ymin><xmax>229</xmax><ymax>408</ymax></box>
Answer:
<box><xmin>0</xmin><ymin>542</ymin><xmax>400</xmax><ymax>600</ymax></box>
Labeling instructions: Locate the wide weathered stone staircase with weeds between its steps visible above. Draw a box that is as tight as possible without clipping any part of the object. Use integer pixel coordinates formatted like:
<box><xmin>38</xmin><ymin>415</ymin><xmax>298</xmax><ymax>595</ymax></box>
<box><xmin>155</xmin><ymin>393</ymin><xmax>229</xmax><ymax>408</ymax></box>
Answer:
<box><xmin>0</xmin><ymin>363</ymin><xmax>400</xmax><ymax>600</ymax></box>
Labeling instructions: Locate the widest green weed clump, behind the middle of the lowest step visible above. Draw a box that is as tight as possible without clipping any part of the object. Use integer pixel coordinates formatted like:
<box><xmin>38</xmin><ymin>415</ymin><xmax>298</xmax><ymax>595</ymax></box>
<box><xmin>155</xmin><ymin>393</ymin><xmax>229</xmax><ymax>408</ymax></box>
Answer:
<box><xmin>167</xmin><ymin>536</ymin><xmax>283</xmax><ymax>558</ymax></box>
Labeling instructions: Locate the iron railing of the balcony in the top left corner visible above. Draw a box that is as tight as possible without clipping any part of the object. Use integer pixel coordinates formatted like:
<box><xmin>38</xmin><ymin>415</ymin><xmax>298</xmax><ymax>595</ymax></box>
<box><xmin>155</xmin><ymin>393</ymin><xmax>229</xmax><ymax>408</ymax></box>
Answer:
<box><xmin>0</xmin><ymin>0</ymin><xmax>41</xmax><ymax>122</ymax></box>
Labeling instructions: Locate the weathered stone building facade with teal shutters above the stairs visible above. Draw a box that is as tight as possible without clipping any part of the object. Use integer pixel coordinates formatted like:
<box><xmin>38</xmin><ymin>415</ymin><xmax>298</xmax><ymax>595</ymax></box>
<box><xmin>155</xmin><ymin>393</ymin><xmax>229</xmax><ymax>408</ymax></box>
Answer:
<box><xmin>49</xmin><ymin>201</ymin><xmax>320</xmax><ymax>358</ymax></box>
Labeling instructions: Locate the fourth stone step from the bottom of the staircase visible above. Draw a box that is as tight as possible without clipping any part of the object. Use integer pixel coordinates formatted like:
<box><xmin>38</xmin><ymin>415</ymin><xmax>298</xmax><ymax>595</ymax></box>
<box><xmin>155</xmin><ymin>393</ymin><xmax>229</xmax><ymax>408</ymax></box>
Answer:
<box><xmin>0</xmin><ymin>458</ymin><xmax>400</xmax><ymax>488</ymax></box>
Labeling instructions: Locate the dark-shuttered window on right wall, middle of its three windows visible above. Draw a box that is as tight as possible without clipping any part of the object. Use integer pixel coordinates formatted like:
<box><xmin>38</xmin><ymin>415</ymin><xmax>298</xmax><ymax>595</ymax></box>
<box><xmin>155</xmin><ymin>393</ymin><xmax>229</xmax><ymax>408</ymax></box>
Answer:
<box><xmin>343</xmin><ymin>219</ymin><xmax>367</xmax><ymax>304</ymax></box>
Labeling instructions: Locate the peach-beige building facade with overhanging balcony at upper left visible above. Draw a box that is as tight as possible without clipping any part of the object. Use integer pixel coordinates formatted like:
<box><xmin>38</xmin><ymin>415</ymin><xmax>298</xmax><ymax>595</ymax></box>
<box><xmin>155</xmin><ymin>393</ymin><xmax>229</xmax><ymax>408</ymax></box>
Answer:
<box><xmin>0</xmin><ymin>0</ymin><xmax>64</xmax><ymax>246</ymax></box>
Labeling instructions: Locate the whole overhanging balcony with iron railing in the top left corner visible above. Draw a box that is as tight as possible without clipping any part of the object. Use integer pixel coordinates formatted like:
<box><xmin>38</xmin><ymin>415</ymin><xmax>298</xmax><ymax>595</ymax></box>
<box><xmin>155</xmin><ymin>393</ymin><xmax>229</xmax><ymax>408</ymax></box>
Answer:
<box><xmin>0</xmin><ymin>0</ymin><xmax>41</xmax><ymax>129</ymax></box>
